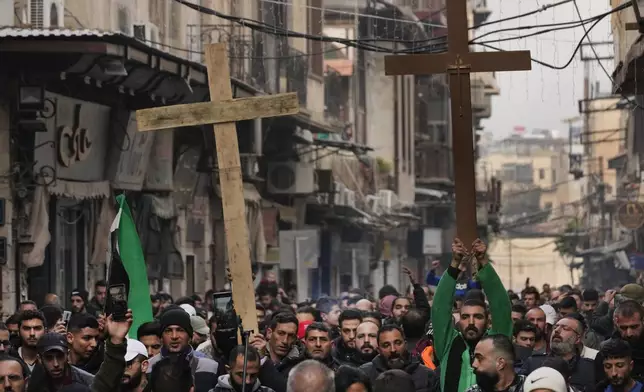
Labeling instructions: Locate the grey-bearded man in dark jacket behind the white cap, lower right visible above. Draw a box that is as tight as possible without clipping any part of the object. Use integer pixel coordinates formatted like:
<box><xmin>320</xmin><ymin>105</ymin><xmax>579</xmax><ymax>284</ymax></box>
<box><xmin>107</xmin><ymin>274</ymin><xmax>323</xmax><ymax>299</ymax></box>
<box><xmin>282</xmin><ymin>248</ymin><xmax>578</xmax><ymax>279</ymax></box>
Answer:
<box><xmin>519</xmin><ymin>314</ymin><xmax>602</xmax><ymax>391</ymax></box>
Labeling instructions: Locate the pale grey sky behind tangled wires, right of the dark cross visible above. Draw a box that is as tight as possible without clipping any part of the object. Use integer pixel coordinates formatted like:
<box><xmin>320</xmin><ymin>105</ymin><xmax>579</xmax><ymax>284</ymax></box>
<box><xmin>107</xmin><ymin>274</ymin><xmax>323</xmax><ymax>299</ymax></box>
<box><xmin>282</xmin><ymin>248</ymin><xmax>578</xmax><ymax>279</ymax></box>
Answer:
<box><xmin>480</xmin><ymin>0</ymin><xmax>616</xmax><ymax>139</ymax></box>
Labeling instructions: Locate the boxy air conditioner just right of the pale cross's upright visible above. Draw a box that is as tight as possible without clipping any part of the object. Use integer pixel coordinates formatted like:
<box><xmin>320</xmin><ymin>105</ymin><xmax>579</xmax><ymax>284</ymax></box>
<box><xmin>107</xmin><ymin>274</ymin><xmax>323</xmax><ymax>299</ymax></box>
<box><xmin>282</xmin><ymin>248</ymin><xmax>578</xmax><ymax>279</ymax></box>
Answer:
<box><xmin>266</xmin><ymin>162</ymin><xmax>315</xmax><ymax>195</ymax></box>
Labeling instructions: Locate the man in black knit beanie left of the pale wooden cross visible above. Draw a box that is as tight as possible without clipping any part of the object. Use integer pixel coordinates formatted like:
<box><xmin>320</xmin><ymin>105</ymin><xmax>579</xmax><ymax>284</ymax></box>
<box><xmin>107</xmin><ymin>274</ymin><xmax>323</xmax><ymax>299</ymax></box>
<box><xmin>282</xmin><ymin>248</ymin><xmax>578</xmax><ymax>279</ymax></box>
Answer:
<box><xmin>147</xmin><ymin>308</ymin><xmax>225</xmax><ymax>392</ymax></box>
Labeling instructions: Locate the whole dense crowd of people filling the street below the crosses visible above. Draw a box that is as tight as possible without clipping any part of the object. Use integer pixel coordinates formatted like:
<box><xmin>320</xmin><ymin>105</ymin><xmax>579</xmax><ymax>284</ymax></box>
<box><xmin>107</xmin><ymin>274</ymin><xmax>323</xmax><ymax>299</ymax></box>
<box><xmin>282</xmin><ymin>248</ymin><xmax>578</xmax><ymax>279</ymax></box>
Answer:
<box><xmin>0</xmin><ymin>239</ymin><xmax>644</xmax><ymax>392</ymax></box>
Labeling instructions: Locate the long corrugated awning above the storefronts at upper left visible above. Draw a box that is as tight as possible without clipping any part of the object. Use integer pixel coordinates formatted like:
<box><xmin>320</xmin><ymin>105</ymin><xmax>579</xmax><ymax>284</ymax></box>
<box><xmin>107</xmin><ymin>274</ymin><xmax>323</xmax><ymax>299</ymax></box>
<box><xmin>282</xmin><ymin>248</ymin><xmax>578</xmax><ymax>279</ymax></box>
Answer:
<box><xmin>0</xmin><ymin>27</ymin><xmax>261</xmax><ymax>107</ymax></box>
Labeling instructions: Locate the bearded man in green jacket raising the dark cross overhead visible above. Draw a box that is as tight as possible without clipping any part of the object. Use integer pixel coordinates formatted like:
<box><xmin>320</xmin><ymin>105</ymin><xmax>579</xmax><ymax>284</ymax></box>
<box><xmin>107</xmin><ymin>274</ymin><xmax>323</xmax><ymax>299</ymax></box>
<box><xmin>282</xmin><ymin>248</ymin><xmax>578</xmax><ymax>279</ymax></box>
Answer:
<box><xmin>432</xmin><ymin>238</ymin><xmax>512</xmax><ymax>392</ymax></box>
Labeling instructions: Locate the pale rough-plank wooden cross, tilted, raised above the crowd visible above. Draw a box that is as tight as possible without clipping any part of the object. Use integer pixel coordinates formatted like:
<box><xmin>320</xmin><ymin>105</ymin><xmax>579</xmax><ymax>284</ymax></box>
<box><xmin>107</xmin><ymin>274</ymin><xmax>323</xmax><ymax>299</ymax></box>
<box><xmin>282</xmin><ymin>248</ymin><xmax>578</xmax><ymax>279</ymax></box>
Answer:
<box><xmin>136</xmin><ymin>44</ymin><xmax>299</xmax><ymax>333</ymax></box>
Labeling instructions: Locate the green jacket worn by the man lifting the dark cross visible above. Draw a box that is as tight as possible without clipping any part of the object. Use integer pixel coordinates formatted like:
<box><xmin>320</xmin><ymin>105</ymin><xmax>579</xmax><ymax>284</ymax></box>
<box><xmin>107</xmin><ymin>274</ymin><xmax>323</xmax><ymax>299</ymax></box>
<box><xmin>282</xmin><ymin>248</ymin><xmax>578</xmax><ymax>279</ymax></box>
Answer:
<box><xmin>432</xmin><ymin>263</ymin><xmax>512</xmax><ymax>392</ymax></box>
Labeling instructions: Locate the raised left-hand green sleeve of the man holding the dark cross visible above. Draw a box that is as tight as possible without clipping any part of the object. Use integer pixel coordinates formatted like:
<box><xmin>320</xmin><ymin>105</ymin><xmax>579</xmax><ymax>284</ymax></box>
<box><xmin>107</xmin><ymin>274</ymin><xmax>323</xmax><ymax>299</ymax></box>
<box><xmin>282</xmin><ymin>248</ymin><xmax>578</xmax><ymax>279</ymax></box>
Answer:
<box><xmin>432</xmin><ymin>266</ymin><xmax>459</xmax><ymax>360</ymax></box>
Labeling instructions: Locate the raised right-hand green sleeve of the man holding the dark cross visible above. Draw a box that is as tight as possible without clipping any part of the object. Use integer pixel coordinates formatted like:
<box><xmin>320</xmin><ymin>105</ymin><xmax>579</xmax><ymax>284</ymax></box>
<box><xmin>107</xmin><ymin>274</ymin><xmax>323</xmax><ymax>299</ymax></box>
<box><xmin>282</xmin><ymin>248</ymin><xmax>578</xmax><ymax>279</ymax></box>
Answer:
<box><xmin>477</xmin><ymin>263</ymin><xmax>512</xmax><ymax>337</ymax></box>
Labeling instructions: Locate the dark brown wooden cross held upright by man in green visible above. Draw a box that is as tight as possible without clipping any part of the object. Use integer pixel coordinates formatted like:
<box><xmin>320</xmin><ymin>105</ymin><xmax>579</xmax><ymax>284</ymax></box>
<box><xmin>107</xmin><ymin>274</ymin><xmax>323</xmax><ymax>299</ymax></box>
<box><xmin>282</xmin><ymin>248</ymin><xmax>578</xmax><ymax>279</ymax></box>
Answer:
<box><xmin>385</xmin><ymin>0</ymin><xmax>531</xmax><ymax>244</ymax></box>
